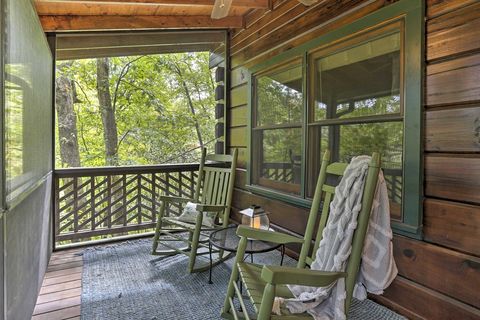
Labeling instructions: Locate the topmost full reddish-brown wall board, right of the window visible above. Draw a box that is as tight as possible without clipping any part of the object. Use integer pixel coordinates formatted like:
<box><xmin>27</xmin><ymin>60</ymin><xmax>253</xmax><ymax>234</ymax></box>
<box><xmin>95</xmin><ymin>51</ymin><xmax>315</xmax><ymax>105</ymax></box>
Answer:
<box><xmin>427</xmin><ymin>2</ymin><xmax>480</xmax><ymax>61</ymax></box>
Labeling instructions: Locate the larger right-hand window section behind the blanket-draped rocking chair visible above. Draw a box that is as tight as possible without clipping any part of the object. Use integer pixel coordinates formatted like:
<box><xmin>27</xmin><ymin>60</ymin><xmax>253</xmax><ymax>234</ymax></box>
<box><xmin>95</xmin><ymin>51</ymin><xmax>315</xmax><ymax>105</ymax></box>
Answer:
<box><xmin>307</xmin><ymin>24</ymin><xmax>403</xmax><ymax>221</ymax></box>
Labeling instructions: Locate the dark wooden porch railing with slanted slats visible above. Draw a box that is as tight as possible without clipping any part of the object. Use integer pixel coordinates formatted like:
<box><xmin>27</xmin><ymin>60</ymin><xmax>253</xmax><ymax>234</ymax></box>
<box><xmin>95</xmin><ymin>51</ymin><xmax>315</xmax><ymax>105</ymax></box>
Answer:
<box><xmin>54</xmin><ymin>164</ymin><xmax>198</xmax><ymax>246</ymax></box>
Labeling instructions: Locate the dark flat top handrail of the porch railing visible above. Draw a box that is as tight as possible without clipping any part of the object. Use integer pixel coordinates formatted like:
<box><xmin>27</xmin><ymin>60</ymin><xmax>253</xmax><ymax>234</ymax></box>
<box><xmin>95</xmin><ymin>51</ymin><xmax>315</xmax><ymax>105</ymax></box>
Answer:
<box><xmin>54</xmin><ymin>163</ymin><xmax>199</xmax><ymax>178</ymax></box>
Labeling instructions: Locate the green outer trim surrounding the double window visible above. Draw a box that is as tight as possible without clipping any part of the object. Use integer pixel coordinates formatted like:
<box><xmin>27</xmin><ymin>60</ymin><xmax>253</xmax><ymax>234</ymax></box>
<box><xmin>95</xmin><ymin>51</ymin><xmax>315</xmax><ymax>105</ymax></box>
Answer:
<box><xmin>247</xmin><ymin>0</ymin><xmax>425</xmax><ymax>239</ymax></box>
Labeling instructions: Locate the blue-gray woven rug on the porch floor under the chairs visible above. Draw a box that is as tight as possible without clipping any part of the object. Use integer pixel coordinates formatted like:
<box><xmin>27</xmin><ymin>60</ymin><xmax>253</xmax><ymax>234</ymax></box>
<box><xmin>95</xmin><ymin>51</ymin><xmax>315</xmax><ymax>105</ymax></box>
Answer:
<box><xmin>81</xmin><ymin>239</ymin><xmax>405</xmax><ymax>320</ymax></box>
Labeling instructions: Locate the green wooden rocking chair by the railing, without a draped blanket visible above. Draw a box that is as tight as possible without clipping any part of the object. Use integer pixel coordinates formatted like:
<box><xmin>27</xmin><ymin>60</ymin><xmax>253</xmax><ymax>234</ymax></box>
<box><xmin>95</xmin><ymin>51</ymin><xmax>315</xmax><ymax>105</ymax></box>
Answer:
<box><xmin>152</xmin><ymin>149</ymin><xmax>237</xmax><ymax>273</ymax></box>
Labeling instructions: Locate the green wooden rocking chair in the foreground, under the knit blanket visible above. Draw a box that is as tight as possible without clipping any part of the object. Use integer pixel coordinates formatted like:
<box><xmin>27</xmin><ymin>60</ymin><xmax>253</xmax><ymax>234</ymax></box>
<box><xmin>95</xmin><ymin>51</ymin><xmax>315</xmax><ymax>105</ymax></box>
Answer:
<box><xmin>222</xmin><ymin>151</ymin><xmax>380</xmax><ymax>320</ymax></box>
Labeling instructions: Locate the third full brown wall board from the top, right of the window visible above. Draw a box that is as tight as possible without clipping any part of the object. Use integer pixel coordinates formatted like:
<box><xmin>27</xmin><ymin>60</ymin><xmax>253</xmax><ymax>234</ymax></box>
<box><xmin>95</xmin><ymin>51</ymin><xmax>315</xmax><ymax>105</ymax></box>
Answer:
<box><xmin>425</xmin><ymin>106</ymin><xmax>480</xmax><ymax>152</ymax></box>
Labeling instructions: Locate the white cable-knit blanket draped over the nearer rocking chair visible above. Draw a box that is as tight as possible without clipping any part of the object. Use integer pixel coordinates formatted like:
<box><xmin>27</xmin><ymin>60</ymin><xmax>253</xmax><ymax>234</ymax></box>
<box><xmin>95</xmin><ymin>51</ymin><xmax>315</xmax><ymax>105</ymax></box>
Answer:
<box><xmin>273</xmin><ymin>156</ymin><xmax>397</xmax><ymax>320</ymax></box>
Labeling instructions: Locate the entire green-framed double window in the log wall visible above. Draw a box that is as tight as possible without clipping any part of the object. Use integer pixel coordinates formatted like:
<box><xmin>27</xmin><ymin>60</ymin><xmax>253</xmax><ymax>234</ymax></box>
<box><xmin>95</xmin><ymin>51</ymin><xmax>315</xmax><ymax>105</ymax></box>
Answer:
<box><xmin>248</xmin><ymin>1</ymin><xmax>423</xmax><ymax>238</ymax></box>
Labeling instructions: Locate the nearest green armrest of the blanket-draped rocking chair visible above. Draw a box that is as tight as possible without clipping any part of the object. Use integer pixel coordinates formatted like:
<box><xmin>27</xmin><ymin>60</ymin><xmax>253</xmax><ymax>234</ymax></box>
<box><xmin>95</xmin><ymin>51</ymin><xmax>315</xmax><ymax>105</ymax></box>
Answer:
<box><xmin>261</xmin><ymin>266</ymin><xmax>347</xmax><ymax>287</ymax></box>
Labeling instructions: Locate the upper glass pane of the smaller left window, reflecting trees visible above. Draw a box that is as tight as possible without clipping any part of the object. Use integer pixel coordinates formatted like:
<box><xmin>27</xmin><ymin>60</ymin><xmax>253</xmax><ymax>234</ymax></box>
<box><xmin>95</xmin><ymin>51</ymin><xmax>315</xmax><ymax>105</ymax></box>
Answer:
<box><xmin>256</xmin><ymin>65</ymin><xmax>303</xmax><ymax>127</ymax></box>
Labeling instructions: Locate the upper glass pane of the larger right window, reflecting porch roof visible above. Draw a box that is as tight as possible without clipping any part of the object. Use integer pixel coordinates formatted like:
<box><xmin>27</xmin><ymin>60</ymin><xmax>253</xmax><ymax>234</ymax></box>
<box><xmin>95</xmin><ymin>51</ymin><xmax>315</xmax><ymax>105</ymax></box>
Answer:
<box><xmin>314</xmin><ymin>33</ymin><xmax>401</xmax><ymax>121</ymax></box>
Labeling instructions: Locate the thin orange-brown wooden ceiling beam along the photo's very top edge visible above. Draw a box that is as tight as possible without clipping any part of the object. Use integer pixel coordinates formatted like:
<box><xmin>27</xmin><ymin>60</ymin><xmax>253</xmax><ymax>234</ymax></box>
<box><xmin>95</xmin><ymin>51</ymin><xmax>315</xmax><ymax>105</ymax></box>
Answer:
<box><xmin>35</xmin><ymin>0</ymin><xmax>270</xmax><ymax>9</ymax></box>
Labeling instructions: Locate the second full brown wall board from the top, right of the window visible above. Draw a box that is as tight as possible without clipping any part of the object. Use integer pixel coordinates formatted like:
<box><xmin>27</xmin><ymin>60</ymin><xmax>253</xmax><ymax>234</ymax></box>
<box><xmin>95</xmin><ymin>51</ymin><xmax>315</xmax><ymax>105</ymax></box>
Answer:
<box><xmin>426</xmin><ymin>54</ymin><xmax>480</xmax><ymax>106</ymax></box>
